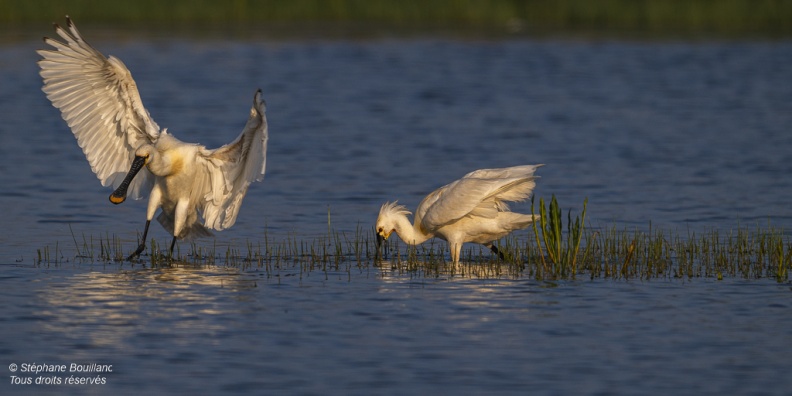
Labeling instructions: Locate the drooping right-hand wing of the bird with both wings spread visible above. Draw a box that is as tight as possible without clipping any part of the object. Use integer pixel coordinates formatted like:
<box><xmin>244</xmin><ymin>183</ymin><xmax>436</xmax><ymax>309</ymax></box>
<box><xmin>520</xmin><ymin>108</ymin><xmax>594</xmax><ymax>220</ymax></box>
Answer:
<box><xmin>200</xmin><ymin>90</ymin><xmax>269</xmax><ymax>230</ymax></box>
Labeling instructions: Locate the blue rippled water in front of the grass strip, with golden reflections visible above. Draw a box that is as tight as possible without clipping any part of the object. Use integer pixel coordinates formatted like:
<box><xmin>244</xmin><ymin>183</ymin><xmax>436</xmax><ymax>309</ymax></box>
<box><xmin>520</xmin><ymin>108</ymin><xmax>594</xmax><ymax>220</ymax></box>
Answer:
<box><xmin>0</xmin><ymin>266</ymin><xmax>792</xmax><ymax>395</ymax></box>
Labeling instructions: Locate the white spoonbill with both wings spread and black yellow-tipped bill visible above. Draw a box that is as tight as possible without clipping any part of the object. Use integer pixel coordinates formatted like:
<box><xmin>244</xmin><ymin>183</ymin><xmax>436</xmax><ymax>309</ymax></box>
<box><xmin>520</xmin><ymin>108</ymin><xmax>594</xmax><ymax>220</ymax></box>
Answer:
<box><xmin>37</xmin><ymin>16</ymin><xmax>268</xmax><ymax>260</ymax></box>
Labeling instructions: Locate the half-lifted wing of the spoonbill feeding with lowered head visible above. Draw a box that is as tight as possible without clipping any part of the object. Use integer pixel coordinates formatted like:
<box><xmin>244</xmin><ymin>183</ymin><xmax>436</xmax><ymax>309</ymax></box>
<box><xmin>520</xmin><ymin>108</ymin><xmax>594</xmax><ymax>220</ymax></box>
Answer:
<box><xmin>415</xmin><ymin>165</ymin><xmax>542</xmax><ymax>231</ymax></box>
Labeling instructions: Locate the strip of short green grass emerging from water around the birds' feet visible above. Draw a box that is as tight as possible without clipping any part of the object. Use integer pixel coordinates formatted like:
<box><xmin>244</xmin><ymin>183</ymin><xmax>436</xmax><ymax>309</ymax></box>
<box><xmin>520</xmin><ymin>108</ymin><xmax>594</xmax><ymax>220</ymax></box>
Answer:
<box><xmin>34</xmin><ymin>197</ymin><xmax>792</xmax><ymax>282</ymax></box>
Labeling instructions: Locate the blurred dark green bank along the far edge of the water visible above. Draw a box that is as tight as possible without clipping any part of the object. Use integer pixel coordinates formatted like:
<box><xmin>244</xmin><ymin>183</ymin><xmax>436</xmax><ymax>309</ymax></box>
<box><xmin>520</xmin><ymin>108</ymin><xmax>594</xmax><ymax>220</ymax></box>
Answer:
<box><xmin>0</xmin><ymin>0</ymin><xmax>792</xmax><ymax>35</ymax></box>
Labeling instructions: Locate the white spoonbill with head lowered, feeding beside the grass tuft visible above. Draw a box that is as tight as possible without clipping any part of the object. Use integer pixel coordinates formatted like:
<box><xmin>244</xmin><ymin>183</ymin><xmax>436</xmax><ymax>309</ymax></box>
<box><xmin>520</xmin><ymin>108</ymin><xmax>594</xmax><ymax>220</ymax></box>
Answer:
<box><xmin>375</xmin><ymin>164</ymin><xmax>543</xmax><ymax>264</ymax></box>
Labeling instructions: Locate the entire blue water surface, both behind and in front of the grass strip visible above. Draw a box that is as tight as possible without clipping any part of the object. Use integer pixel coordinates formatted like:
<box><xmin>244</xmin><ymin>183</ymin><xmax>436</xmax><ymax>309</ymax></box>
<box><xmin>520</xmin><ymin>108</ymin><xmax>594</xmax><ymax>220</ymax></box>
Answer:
<box><xmin>0</xmin><ymin>29</ymin><xmax>792</xmax><ymax>394</ymax></box>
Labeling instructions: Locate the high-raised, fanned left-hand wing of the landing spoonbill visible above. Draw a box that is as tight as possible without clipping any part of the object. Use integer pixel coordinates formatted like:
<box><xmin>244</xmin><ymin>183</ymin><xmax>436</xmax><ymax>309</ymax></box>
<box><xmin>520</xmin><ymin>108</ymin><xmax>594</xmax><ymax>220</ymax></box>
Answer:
<box><xmin>36</xmin><ymin>16</ymin><xmax>159</xmax><ymax>199</ymax></box>
